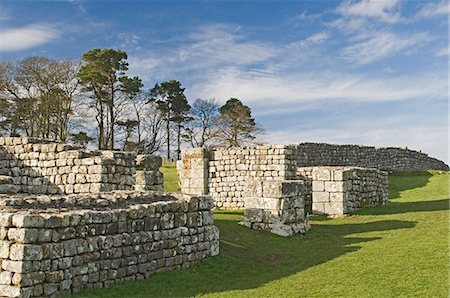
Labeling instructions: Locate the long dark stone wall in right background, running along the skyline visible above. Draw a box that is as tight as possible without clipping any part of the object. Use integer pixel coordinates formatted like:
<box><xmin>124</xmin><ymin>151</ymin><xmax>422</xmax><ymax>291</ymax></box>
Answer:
<box><xmin>294</xmin><ymin>143</ymin><xmax>449</xmax><ymax>171</ymax></box>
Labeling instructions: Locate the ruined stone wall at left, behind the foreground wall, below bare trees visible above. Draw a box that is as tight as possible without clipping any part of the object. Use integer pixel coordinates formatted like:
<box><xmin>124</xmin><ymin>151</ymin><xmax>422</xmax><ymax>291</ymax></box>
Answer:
<box><xmin>0</xmin><ymin>137</ymin><xmax>163</xmax><ymax>194</ymax></box>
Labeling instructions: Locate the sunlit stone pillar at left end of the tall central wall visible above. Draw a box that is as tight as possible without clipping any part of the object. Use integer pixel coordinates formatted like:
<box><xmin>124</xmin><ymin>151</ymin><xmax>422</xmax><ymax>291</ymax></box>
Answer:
<box><xmin>177</xmin><ymin>148</ymin><xmax>209</xmax><ymax>195</ymax></box>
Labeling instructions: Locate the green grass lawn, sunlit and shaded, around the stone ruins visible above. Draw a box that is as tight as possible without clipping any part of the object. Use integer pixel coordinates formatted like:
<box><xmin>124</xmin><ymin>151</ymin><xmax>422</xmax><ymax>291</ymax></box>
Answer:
<box><xmin>74</xmin><ymin>172</ymin><xmax>450</xmax><ymax>297</ymax></box>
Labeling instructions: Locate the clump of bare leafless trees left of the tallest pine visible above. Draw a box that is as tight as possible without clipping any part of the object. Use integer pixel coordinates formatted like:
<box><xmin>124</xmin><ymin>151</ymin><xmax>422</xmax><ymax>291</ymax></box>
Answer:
<box><xmin>0</xmin><ymin>57</ymin><xmax>78</xmax><ymax>141</ymax></box>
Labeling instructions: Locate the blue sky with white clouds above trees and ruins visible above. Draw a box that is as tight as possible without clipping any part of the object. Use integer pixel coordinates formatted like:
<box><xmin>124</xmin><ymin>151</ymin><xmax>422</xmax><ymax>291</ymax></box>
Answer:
<box><xmin>0</xmin><ymin>0</ymin><xmax>449</xmax><ymax>163</ymax></box>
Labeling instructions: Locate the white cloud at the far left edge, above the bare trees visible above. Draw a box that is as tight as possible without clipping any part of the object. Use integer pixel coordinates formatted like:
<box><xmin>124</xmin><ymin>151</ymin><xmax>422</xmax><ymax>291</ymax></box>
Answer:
<box><xmin>0</xmin><ymin>24</ymin><xmax>59</xmax><ymax>52</ymax></box>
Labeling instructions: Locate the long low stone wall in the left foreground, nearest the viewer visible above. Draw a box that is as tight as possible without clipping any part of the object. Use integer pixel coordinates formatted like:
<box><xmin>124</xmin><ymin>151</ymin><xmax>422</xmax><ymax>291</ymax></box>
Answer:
<box><xmin>0</xmin><ymin>192</ymin><xmax>219</xmax><ymax>297</ymax></box>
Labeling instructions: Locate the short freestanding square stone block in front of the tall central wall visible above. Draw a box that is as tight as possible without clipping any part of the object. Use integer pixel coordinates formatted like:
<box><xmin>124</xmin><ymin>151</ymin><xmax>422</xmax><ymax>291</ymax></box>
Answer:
<box><xmin>240</xmin><ymin>180</ymin><xmax>309</xmax><ymax>237</ymax></box>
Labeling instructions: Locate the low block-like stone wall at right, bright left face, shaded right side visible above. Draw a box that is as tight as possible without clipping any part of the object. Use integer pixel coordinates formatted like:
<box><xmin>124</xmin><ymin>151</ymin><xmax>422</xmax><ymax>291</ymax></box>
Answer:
<box><xmin>311</xmin><ymin>167</ymin><xmax>388</xmax><ymax>216</ymax></box>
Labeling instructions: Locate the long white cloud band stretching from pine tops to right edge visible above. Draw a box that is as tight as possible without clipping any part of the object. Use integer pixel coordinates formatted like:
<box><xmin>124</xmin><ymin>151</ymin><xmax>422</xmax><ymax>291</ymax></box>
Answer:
<box><xmin>189</xmin><ymin>68</ymin><xmax>447</xmax><ymax>109</ymax></box>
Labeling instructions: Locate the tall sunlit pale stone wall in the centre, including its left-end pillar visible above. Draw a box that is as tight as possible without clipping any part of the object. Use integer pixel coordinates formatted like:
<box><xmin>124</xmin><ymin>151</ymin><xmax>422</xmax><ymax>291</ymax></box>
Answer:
<box><xmin>177</xmin><ymin>146</ymin><xmax>289</xmax><ymax>209</ymax></box>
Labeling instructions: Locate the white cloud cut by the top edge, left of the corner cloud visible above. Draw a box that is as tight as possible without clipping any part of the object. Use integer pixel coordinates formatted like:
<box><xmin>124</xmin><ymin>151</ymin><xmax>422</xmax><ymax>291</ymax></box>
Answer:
<box><xmin>336</xmin><ymin>0</ymin><xmax>401</xmax><ymax>23</ymax></box>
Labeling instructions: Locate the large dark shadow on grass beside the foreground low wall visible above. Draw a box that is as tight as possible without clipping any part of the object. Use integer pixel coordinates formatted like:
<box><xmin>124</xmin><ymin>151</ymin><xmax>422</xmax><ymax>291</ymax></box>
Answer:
<box><xmin>75</xmin><ymin>212</ymin><xmax>416</xmax><ymax>297</ymax></box>
